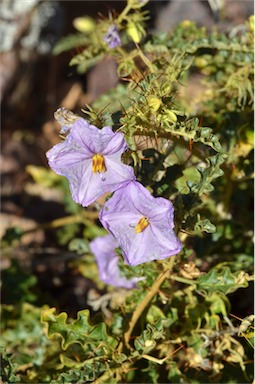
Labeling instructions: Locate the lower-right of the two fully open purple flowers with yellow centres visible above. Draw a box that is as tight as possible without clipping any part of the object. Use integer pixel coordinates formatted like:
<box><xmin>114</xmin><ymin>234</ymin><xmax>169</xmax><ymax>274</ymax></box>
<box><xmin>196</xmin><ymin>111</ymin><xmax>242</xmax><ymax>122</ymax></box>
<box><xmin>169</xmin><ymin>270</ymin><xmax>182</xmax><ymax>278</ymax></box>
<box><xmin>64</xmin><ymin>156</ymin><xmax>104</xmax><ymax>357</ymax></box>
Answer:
<box><xmin>99</xmin><ymin>181</ymin><xmax>182</xmax><ymax>265</ymax></box>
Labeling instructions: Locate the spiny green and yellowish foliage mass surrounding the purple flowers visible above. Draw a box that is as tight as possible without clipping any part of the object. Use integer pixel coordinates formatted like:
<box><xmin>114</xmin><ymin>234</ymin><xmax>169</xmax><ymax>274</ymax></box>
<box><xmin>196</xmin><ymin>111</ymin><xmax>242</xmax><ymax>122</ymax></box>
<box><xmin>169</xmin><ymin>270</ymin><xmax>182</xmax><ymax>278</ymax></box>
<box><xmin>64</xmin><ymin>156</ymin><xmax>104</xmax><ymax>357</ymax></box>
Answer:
<box><xmin>1</xmin><ymin>0</ymin><xmax>254</xmax><ymax>383</ymax></box>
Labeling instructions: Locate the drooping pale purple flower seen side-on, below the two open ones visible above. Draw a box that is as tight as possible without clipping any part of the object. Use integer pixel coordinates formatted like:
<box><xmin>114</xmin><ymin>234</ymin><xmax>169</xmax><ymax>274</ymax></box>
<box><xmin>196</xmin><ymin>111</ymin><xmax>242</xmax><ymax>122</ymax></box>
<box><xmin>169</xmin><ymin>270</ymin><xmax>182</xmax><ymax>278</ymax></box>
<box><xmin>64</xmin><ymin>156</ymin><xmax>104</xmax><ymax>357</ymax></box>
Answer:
<box><xmin>90</xmin><ymin>235</ymin><xmax>144</xmax><ymax>289</ymax></box>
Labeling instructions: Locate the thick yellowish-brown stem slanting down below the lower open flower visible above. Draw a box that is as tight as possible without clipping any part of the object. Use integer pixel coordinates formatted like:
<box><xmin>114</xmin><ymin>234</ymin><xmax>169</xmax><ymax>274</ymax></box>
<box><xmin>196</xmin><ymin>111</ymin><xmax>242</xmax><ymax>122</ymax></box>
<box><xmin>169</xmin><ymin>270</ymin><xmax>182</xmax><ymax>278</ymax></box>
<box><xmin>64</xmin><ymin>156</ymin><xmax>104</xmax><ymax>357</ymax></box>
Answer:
<box><xmin>124</xmin><ymin>256</ymin><xmax>175</xmax><ymax>349</ymax></box>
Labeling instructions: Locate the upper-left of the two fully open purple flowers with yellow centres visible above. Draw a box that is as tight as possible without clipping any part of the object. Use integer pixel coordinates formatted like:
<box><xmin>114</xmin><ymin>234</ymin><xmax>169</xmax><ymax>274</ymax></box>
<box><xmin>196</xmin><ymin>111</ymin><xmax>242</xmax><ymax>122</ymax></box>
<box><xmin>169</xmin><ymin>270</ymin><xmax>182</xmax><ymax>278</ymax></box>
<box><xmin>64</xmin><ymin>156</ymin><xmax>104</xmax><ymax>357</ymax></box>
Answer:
<box><xmin>46</xmin><ymin>118</ymin><xmax>135</xmax><ymax>207</ymax></box>
